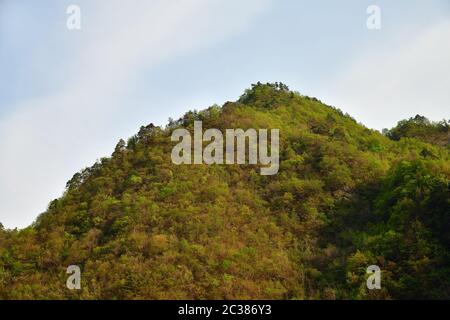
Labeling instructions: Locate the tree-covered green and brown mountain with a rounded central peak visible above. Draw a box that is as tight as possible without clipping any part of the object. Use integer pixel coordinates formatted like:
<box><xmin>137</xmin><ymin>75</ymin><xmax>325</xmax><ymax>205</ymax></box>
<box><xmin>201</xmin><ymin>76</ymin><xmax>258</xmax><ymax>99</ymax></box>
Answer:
<box><xmin>0</xmin><ymin>83</ymin><xmax>450</xmax><ymax>299</ymax></box>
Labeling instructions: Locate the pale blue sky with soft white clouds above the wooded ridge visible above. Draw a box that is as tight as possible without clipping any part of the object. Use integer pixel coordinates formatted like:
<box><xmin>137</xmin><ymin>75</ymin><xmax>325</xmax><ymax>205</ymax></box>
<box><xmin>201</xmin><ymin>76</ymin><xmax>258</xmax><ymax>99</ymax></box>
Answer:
<box><xmin>0</xmin><ymin>0</ymin><xmax>450</xmax><ymax>228</ymax></box>
